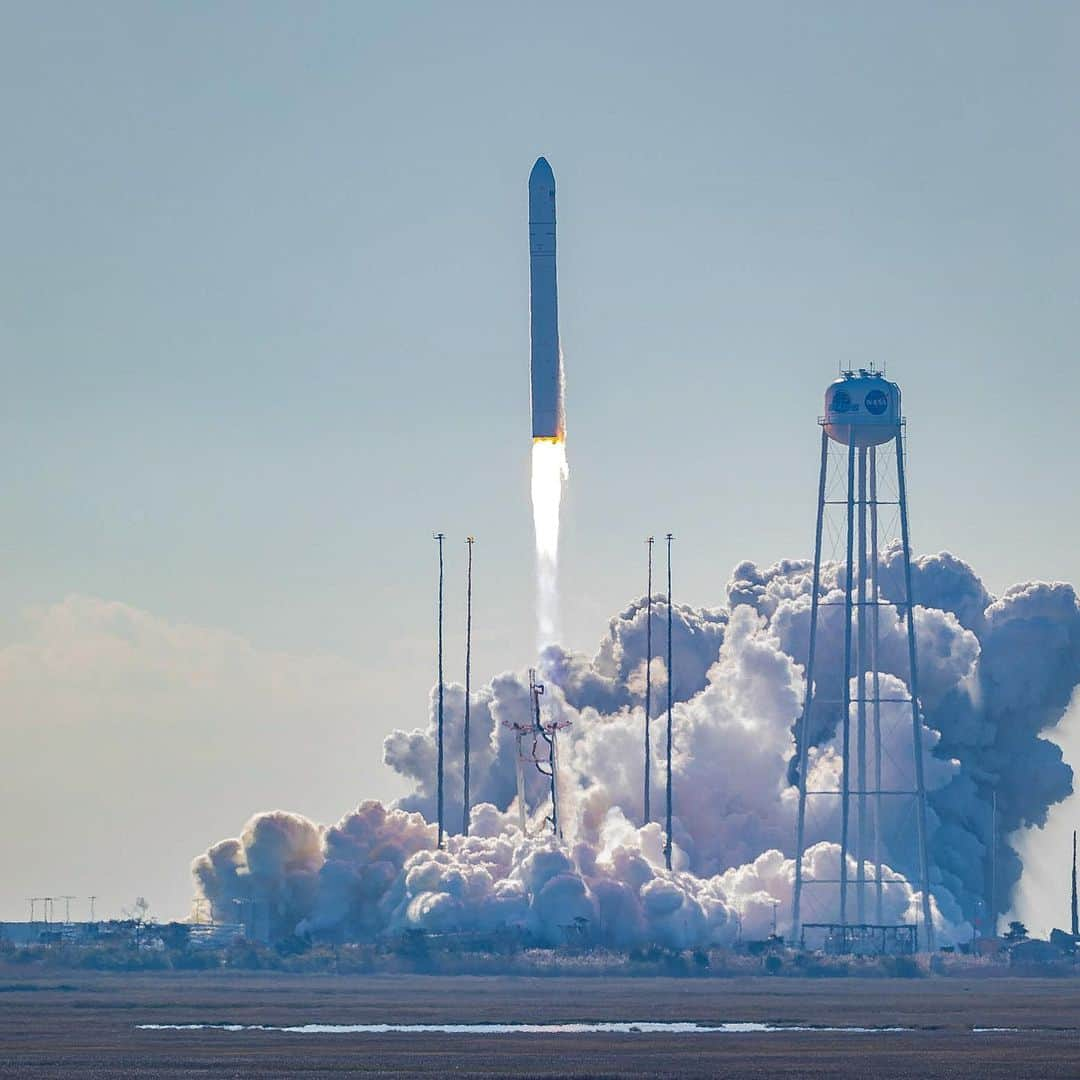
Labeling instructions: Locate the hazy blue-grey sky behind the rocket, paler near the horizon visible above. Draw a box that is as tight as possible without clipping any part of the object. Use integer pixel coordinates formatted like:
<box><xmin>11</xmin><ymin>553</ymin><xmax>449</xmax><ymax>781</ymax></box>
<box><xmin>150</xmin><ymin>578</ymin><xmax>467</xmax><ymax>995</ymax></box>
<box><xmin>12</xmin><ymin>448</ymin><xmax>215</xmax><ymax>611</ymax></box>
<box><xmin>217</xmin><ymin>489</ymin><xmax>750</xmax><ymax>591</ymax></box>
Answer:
<box><xmin>0</xmin><ymin>0</ymin><xmax>1080</xmax><ymax>918</ymax></box>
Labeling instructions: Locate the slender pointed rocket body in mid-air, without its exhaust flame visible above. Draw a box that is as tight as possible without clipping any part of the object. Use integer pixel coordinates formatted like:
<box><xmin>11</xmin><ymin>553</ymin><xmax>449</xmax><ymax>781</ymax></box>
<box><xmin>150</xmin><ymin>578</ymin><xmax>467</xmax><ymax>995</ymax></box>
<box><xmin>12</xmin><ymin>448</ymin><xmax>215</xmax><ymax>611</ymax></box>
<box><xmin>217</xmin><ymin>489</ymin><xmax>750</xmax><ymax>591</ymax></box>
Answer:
<box><xmin>529</xmin><ymin>158</ymin><xmax>566</xmax><ymax>442</ymax></box>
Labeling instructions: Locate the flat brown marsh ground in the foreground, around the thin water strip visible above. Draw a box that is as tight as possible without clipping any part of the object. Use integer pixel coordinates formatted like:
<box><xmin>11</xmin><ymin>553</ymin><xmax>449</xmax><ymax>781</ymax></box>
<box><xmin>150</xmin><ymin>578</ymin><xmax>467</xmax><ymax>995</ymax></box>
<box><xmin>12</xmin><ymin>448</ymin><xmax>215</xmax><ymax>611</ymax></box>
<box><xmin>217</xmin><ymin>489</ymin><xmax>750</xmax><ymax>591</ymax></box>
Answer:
<box><xmin>0</xmin><ymin>971</ymin><xmax>1080</xmax><ymax>1078</ymax></box>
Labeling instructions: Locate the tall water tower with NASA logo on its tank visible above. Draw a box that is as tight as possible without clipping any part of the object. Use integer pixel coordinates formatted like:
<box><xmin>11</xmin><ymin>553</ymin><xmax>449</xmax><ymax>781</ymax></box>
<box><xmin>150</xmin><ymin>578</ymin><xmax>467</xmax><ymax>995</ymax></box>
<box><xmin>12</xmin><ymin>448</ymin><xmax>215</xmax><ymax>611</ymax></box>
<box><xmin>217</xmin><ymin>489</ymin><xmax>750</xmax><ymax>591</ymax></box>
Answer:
<box><xmin>792</xmin><ymin>369</ymin><xmax>933</xmax><ymax>949</ymax></box>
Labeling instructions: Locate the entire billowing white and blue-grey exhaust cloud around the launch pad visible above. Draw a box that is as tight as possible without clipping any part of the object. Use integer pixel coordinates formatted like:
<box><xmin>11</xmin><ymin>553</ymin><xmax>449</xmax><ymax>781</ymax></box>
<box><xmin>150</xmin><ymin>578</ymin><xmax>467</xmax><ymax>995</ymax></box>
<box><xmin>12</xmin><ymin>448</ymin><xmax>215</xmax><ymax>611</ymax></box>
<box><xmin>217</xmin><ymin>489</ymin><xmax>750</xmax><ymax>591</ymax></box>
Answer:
<box><xmin>194</xmin><ymin>546</ymin><xmax>1080</xmax><ymax>947</ymax></box>
